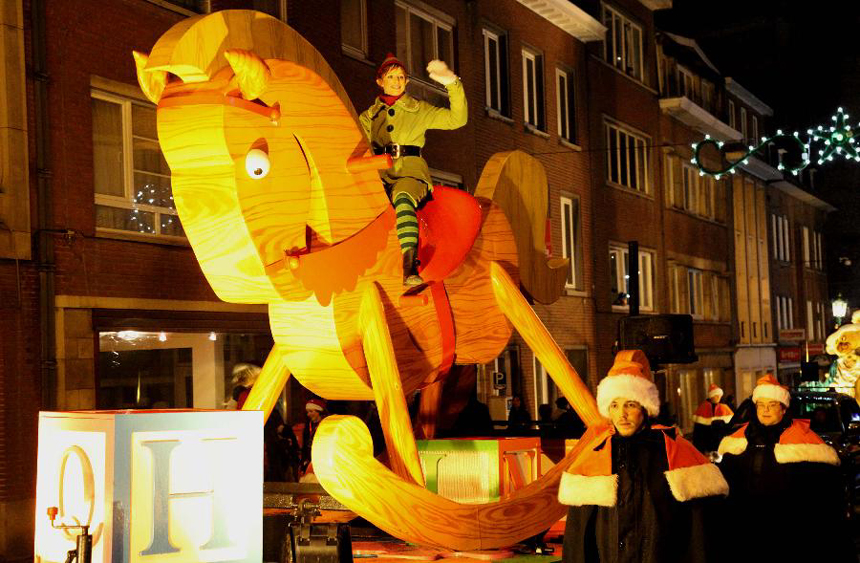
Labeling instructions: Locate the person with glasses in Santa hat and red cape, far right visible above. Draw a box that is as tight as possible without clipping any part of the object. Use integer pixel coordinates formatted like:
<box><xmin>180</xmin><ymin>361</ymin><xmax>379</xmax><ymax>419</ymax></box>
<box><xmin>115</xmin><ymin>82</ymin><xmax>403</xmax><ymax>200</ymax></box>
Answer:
<box><xmin>719</xmin><ymin>375</ymin><xmax>857</xmax><ymax>563</ymax></box>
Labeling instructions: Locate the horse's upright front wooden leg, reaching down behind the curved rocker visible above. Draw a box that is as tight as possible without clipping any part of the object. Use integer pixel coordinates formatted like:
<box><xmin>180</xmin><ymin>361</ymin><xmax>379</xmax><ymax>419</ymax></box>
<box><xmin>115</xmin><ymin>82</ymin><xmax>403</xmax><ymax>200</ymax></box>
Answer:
<box><xmin>358</xmin><ymin>284</ymin><xmax>424</xmax><ymax>486</ymax></box>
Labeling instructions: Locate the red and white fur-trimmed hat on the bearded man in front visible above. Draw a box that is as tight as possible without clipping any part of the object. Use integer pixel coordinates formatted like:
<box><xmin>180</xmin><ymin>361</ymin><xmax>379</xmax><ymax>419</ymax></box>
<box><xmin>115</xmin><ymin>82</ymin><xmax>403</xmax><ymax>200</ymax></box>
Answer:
<box><xmin>597</xmin><ymin>350</ymin><xmax>660</xmax><ymax>418</ymax></box>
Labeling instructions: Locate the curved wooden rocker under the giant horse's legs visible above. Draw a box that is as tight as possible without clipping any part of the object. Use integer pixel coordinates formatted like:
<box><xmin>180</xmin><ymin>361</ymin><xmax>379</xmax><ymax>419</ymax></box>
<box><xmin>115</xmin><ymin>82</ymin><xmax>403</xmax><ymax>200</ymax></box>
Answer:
<box><xmin>312</xmin><ymin>416</ymin><xmax>597</xmax><ymax>551</ymax></box>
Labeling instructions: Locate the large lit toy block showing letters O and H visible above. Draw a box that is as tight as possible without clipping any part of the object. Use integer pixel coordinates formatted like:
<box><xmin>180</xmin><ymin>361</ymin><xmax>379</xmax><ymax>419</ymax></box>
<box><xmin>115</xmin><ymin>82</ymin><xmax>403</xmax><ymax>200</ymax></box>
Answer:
<box><xmin>35</xmin><ymin>410</ymin><xmax>263</xmax><ymax>563</ymax></box>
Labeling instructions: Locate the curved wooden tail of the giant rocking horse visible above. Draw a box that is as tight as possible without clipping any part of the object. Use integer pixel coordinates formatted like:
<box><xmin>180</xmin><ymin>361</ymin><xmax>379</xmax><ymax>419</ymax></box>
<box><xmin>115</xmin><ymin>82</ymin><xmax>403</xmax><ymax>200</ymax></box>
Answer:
<box><xmin>475</xmin><ymin>151</ymin><xmax>570</xmax><ymax>304</ymax></box>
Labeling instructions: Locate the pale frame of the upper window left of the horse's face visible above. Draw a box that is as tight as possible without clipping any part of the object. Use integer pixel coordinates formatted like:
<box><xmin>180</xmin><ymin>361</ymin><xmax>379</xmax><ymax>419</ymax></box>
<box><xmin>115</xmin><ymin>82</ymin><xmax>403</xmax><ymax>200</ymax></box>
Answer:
<box><xmin>90</xmin><ymin>87</ymin><xmax>182</xmax><ymax>243</ymax></box>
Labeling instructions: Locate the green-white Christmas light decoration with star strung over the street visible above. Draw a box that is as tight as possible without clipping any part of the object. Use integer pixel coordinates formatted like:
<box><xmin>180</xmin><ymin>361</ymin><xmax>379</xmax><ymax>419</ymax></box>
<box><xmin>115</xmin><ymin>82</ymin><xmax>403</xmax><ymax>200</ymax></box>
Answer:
<box><xmin>690</xmin><ymin>108</ymin><xmax>860</xmax><ymax>180</ymax></box>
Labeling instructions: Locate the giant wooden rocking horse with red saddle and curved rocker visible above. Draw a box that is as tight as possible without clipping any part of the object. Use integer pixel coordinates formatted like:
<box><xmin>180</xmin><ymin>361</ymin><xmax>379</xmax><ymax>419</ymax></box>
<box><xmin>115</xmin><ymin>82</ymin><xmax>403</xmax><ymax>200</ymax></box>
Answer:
<box><xmin>135</xmin><ymin>10</ymin><xmax>601</xmax><ymax>550</ymax></box>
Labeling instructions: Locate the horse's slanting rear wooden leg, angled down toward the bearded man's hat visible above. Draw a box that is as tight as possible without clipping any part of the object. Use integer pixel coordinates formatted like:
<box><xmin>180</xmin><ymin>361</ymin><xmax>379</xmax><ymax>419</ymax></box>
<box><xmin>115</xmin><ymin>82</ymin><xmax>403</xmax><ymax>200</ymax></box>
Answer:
<box><xmin>490</xmin><ymin>262</ymin><xmax>605</xmax><ymax>426</ymax></box>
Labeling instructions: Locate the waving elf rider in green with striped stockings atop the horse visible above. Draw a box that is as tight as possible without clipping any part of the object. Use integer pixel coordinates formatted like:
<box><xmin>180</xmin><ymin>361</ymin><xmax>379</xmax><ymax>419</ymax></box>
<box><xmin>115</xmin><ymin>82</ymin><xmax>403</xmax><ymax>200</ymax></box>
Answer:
<box><xmin>359</xmin><ymin>53</ymin><xmax>469</xmax><ymax>286</ymax></box>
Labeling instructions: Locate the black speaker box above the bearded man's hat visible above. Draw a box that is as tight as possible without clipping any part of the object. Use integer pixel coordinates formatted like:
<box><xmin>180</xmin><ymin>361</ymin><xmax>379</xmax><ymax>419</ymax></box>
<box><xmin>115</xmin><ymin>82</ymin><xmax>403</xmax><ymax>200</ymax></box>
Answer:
<box><xmin>618</xmin><ymin>315</ymin><xmax>699</xmax><ymax>367</ymax></box>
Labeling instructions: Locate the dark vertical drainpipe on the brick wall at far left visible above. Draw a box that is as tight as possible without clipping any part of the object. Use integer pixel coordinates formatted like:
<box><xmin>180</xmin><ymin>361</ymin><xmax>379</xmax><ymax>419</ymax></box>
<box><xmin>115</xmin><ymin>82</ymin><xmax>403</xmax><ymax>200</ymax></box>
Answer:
<box><xmin>30</xmin><ymin>0</ymin><xmax>57</xmax><ymax>410</ymax></box>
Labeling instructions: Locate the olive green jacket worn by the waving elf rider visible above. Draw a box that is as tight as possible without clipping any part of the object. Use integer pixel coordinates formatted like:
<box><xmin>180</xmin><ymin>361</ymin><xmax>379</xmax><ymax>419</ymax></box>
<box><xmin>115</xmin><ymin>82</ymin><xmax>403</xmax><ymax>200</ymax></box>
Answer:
<box><xmin>359</xmin><ymin>79</ymin><xmax>469</xmax><ymax>186</ymax></box>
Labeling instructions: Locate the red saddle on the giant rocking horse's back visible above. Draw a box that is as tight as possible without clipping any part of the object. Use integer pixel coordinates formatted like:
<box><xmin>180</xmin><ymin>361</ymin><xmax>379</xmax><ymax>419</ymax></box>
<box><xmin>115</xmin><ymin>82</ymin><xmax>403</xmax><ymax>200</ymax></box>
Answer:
<box><xmin>418</xmin><ymin>186</ymin><xmax>481</xmax><ymax>282</ymax></box>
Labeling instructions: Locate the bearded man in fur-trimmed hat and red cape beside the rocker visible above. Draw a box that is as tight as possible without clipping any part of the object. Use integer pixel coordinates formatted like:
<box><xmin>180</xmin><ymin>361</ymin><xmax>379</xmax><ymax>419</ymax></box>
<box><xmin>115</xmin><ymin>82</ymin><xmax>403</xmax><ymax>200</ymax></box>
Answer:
<box><xmin>558</xmin><ymin>350</ymin><xmax>729</xmax><ymax>563</ymax></box>
